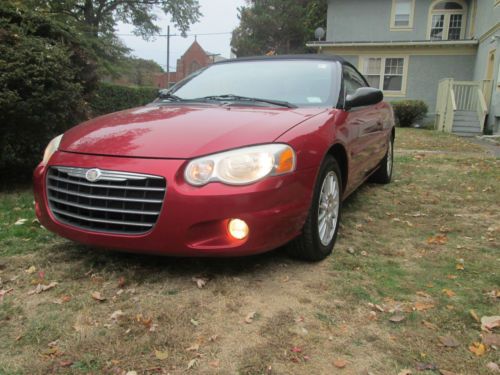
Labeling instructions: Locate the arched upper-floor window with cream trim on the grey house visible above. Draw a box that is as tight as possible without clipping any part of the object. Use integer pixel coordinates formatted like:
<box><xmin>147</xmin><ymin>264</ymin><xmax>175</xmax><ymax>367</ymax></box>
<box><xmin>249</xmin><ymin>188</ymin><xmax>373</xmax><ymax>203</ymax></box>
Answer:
<box><xmin>429</xmin><ymin>1</ymin><xmax>466</xmax><ymax>40</ymax></box>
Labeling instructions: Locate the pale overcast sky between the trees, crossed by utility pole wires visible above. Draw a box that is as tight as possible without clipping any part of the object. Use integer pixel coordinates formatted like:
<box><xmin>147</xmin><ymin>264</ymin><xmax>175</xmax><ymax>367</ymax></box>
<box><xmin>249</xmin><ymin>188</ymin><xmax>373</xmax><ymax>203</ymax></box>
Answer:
<box><xmin>118</xmin><ymin>0</ymin><xmax>245</xmax><ymax>71</ymax></box>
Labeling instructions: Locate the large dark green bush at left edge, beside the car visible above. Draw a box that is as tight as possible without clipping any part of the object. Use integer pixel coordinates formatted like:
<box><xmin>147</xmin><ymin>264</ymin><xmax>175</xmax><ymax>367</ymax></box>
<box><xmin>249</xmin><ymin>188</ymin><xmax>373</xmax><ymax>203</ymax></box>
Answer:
<box><xmin>0</xmin><ymin>3</ymin><xmax>97</xmax><ymax>177</ymax></box>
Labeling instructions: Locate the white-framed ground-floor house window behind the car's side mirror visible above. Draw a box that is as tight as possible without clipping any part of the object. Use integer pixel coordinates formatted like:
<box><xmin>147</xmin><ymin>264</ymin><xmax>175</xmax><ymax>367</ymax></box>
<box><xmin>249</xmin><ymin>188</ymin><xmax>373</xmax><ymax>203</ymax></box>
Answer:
<box><xmin>362</xmin><ymin>57</ymin><xmax>408</xmax><ymax>94</ymax></box>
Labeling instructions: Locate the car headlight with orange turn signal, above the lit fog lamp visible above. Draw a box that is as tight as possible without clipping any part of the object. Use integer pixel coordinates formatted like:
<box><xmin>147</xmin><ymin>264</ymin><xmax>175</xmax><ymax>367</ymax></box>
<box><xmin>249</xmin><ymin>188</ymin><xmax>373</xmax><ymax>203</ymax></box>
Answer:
<box><xmin>188</xmin><ymin>144</ymin><xmax>296</xmax><ymax>186</ymax></box>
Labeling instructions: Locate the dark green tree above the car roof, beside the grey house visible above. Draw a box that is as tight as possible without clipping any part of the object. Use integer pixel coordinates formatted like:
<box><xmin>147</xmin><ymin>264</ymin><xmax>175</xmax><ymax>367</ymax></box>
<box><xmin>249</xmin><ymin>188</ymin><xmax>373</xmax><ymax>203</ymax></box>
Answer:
<box><xmin>231</xmin><ymin>0</ymin><xmax>327</xmax><ymax>56</ymax></box>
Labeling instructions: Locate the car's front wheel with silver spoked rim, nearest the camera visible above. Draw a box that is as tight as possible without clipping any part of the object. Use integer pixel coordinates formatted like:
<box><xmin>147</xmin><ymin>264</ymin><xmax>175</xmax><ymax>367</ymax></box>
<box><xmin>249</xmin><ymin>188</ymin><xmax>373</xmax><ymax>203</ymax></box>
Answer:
<box><xmin>288</xmin><ymin>155</ymin><xmax>342</xmax><ymax>262</ymax></box>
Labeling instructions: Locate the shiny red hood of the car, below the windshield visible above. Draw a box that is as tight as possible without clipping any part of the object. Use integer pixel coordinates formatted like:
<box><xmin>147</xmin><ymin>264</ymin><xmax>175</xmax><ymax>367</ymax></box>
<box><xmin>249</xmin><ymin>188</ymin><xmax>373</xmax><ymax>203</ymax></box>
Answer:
<box><xmin>59</xmin><ymin>105</ymin><xmax>325</xmax><ymax>159</ymax></box>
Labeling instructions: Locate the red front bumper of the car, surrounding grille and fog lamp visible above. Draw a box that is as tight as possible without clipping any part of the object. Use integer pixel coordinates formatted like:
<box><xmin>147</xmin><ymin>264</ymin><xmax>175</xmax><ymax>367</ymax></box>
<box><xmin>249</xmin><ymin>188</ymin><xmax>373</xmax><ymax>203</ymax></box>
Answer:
<box><xmin>34</xmin><ymin>151</ymin><xmax>317</xmax><ymax>256</ymax></box>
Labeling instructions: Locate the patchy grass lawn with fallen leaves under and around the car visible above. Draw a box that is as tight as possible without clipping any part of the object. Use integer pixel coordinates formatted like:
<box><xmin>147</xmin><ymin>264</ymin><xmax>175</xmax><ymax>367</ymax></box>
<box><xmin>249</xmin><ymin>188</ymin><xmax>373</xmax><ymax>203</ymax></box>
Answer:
<box><xmin>0</xmin><ymin>129</ymin><xmax>500</xmax><ymax>375</ymax></box>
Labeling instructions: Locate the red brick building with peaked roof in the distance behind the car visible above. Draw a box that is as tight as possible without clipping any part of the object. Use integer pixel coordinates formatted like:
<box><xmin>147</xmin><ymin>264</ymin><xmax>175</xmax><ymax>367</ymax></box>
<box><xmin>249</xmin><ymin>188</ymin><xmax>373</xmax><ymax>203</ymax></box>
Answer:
<box><xmin>154</xmin><ymin>39</ymin><xmax>221</xmax><ymax>88</ymax></box>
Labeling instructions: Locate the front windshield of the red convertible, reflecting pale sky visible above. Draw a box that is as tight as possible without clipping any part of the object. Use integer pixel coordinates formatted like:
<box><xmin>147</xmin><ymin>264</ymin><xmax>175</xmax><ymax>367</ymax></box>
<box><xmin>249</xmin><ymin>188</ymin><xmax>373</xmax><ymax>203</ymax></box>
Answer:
<box><xmin>171</xmin><ymin>59</ymin><xmax>340</xmax><ymax>107</ymax></box>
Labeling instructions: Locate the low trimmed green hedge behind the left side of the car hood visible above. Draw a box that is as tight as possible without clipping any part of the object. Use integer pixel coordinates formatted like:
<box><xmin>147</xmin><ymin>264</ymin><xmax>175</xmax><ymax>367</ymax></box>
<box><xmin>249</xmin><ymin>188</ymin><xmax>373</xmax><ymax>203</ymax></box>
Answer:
<box><xmin>90</xmin><ymin>83</ymin><xmax>158</xmax><ymax>116</ymax></box>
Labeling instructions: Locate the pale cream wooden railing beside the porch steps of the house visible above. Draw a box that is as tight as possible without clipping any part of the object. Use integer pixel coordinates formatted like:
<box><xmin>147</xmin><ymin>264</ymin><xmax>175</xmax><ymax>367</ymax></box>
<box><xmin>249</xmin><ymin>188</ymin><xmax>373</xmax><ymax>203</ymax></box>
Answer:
<box><xmin>436</xmin><ymin>78</ymin><xmax>488</xmax><ymax>133</ymax></box>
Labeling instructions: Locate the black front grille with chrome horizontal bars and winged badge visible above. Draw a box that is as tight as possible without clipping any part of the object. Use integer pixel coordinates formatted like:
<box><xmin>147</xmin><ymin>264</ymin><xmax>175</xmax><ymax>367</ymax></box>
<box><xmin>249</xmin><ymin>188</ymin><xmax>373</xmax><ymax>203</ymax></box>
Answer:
<box><xmin>47</xmin><ymin>167</ymin><xmax>166</xmax><ymax>234</ymax></box>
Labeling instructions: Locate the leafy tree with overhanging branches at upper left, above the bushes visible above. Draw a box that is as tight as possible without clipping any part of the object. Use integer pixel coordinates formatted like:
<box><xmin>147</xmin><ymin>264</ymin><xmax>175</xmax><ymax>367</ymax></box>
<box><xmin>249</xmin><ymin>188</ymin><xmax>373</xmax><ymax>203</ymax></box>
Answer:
<box><xmin>13</xmin><ymin>0</ymin><xmax>201</xmax><ymax>76</ymax></box>
